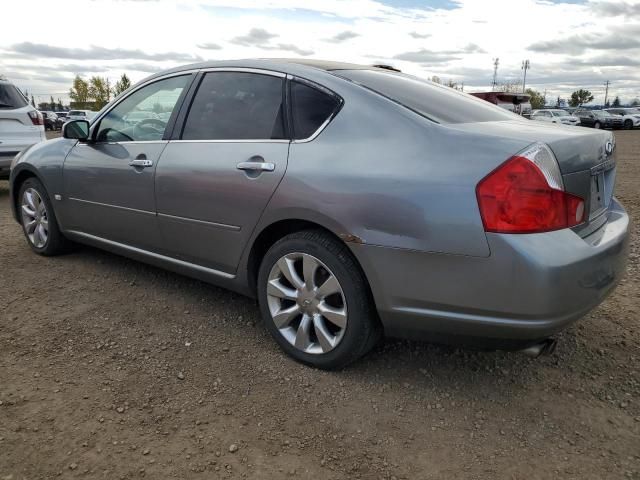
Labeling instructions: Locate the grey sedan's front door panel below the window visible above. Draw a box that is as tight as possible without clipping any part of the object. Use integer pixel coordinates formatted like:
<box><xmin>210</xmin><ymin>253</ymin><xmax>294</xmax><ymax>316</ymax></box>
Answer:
<box><xmin>64</xmin><ymin>141</ymin><xmax>166</xmax><ymax>250</ymax></box>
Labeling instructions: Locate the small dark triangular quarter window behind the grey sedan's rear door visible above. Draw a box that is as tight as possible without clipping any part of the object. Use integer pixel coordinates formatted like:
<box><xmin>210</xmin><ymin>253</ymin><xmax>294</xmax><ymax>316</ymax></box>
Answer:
<box><xmin>291</xmin><ymin>81</ymin><xmax>340</xmax><ymax>140</ymax></box>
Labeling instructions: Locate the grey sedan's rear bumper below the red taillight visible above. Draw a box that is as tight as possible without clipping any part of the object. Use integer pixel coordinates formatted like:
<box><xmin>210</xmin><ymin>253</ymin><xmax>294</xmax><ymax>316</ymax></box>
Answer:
<box><xmin>351</xmin><ymin>200</ymin><xmax>629</xmax><ymax>346</ymax></box>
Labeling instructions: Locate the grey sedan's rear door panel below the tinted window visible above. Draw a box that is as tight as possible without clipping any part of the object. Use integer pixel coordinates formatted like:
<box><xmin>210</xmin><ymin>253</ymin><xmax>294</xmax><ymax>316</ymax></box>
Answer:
<box><xmin>156</xmin><ymin>140</ymin><xmax>289</xmax><ymax>273</ymax></box>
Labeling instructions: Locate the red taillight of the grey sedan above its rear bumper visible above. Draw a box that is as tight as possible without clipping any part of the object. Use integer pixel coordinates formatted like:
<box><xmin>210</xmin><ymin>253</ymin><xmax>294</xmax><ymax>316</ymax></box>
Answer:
<box><xmin>476</xmin><ymin>150</ymin><xmax>584</xmax><ymax>233</ymax></box>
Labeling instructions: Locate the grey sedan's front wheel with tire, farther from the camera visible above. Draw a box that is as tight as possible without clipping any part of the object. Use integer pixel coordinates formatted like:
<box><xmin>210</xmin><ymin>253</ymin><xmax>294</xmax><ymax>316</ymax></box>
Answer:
<box><xmin>17</xmin><ymin>178</ymin><xmax>70</xmax><ymax>256</ymax></box>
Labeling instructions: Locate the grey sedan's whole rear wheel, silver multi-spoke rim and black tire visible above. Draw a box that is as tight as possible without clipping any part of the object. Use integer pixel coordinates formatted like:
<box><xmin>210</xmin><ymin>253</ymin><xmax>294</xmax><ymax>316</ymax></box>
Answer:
<box><xmin>257</xmin><ymin>230</ymin><xmax>381</xmax><ymax>369</ymax></box>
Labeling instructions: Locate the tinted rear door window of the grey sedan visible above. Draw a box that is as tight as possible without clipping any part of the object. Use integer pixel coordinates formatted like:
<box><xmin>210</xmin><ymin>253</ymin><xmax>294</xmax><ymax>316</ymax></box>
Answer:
<box><xmin>182</xmin><ymin>72</ymin><xmax>285</xmax><ymax>140</ymax></box>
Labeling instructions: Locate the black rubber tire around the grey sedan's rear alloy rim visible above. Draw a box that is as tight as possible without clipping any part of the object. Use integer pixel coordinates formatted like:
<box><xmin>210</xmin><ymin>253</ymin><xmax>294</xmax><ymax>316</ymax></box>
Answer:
<box><xmin>257</xmin><ymin>230</ymin><xmax>382</xmax><ymax>370</ymax></box>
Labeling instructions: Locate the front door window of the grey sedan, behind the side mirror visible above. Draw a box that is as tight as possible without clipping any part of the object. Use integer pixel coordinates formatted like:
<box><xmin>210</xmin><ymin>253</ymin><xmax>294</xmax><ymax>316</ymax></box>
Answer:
<box><xmin>95</xmin><ymin>75</ymin><xmax>190</xmax><ymax>142</ymax></box>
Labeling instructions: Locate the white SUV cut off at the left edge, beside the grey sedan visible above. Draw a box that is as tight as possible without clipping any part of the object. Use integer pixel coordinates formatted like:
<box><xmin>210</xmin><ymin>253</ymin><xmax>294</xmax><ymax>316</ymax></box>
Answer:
<box><xmin>0</xmin><ymin>80</ymin><xmax>46</xmax><ymax>178</ymax></box>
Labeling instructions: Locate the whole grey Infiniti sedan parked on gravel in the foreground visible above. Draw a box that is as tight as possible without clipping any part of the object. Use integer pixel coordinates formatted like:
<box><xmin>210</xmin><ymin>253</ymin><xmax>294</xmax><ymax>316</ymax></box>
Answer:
<box><xmin>10</xmin><ymin>60</ymin><xmax>629</xmax><ymax>369</ymax></box>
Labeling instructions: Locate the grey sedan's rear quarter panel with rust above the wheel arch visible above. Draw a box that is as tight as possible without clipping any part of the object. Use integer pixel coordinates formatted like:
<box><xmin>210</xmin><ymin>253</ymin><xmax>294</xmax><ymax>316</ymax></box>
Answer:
<box><xmin>263</xmin><ymin>79</ymin><xmax>527</xmax><ymax>257</ymax></box>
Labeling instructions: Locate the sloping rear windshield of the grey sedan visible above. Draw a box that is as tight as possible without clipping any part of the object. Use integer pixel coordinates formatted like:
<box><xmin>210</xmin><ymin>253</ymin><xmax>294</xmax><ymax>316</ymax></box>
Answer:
<box><xmin>334</xmin><ymin>70</ymin><xmax>520</xmax><ymax>123</ymax></box>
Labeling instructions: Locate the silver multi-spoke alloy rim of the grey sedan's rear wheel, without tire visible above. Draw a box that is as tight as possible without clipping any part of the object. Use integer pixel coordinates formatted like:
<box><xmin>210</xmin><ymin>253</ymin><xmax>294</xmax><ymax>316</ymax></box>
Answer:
<box><xmin>267</xmin><ymin>253</ymin><xmax>347</xmax><ymax>354</ymax></box>
